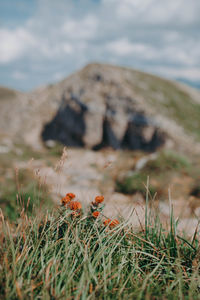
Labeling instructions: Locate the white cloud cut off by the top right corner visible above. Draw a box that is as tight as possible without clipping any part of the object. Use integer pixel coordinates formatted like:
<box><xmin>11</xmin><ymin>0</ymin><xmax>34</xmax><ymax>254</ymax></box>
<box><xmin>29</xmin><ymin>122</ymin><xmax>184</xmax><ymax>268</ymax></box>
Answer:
<box><xmin>103</xmin><ymin>0</ymin><xmax>200</xmax><ymax>25</ymax></box>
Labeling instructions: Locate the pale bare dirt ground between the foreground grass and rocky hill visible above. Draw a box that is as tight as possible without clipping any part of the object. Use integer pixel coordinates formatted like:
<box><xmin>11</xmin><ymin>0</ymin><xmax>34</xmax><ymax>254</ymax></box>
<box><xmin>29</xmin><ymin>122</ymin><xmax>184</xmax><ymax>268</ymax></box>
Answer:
<box><xmin>12</xmin><ymin>149</ymin><xmax>200</xmax><ymax>236</ymax></box>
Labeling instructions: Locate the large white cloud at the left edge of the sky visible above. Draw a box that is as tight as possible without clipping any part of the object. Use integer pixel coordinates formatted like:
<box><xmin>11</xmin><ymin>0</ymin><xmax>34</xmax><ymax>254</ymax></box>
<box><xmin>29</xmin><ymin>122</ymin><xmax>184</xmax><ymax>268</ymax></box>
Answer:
<box><xmin>0</xmin><ymin>11</ymin><xmax>98</xmax><ymax>64</ymax></box>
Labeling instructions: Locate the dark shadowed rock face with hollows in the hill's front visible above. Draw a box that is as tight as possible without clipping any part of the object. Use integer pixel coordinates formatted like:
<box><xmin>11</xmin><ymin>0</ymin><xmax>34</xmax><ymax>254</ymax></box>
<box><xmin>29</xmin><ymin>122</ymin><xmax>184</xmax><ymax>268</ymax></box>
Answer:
<box><xmin>42</xmin><ymin>85</ymin><xmax>166</xmax><ymax>151</ymax></box>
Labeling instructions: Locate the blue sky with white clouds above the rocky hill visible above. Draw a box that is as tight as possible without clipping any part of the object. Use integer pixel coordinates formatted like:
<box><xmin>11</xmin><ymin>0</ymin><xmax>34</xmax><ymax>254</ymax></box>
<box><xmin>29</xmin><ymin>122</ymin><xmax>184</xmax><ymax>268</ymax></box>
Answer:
<box><xmin>0</xmin><ymin>0</ymin><xmax>200</xmax><ymax>91</ymax></box>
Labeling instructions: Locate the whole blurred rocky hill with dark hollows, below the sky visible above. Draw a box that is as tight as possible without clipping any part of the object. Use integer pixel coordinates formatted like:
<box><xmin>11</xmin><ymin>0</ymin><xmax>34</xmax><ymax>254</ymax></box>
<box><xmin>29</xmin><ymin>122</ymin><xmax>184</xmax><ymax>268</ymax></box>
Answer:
<box><xmin>0</xmin><ymin>64</ymin><xmax>200</xmax><ymax>151</ymax></box>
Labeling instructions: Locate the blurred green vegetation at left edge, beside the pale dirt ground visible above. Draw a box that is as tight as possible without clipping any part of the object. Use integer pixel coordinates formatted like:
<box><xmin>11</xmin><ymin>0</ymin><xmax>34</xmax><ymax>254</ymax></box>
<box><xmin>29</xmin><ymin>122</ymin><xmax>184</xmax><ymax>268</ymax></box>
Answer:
<box><xmin>0</xmin><ymin>145</ymin><xmax>52</xmax><ymax>220</ymax></box>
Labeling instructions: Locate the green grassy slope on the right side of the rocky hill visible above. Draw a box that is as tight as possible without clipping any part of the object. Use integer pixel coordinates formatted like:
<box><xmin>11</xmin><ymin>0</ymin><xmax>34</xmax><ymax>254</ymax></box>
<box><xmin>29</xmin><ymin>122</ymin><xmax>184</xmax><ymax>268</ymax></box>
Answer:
<box><xmin>130</xmin><ymin>72</ymin><xmax>200</xmax><ymax>140</ymax></box>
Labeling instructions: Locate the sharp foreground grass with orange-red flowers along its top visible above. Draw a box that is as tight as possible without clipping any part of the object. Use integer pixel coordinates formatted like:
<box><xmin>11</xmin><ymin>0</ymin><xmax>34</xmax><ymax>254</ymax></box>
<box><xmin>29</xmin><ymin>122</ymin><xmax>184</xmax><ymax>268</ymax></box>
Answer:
<box><xmin>0</xmin><ymin>193</ymin><xmax>200</xmax><ymax>299</ymax></box>
